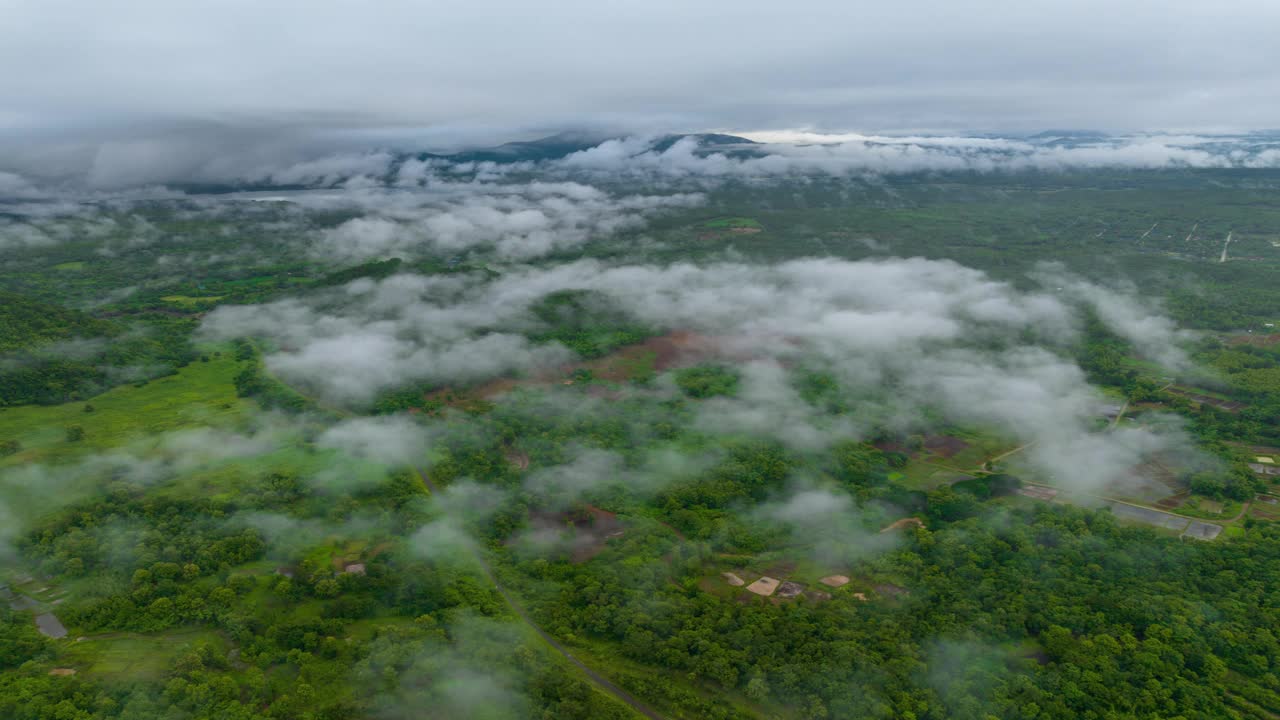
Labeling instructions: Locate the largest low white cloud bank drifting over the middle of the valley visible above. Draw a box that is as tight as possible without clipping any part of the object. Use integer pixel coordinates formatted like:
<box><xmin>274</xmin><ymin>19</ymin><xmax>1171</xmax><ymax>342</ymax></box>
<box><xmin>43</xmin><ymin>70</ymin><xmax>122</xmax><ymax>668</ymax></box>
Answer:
<box><xmin>205</xmin><ymin>259</ymin><xmax>1185</xmax><ymax>497</ymax></box>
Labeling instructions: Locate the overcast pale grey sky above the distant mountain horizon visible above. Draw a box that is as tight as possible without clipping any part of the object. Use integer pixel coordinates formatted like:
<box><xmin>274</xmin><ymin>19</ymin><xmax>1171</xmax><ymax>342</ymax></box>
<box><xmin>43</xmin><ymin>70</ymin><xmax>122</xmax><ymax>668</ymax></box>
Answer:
<box><xmin>0</xmin><ymin>0</ymin><xmax>1280</xmax><ymax>137</ymax></box>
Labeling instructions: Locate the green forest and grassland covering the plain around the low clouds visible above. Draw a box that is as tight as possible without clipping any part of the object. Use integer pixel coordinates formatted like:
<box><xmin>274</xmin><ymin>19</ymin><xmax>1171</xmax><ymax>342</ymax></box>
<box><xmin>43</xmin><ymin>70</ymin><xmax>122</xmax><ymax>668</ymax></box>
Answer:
<box><xmin>0</xmin><ymin>170</ymin><xmax>1280</xmax><ymax>720</ymax></box>
